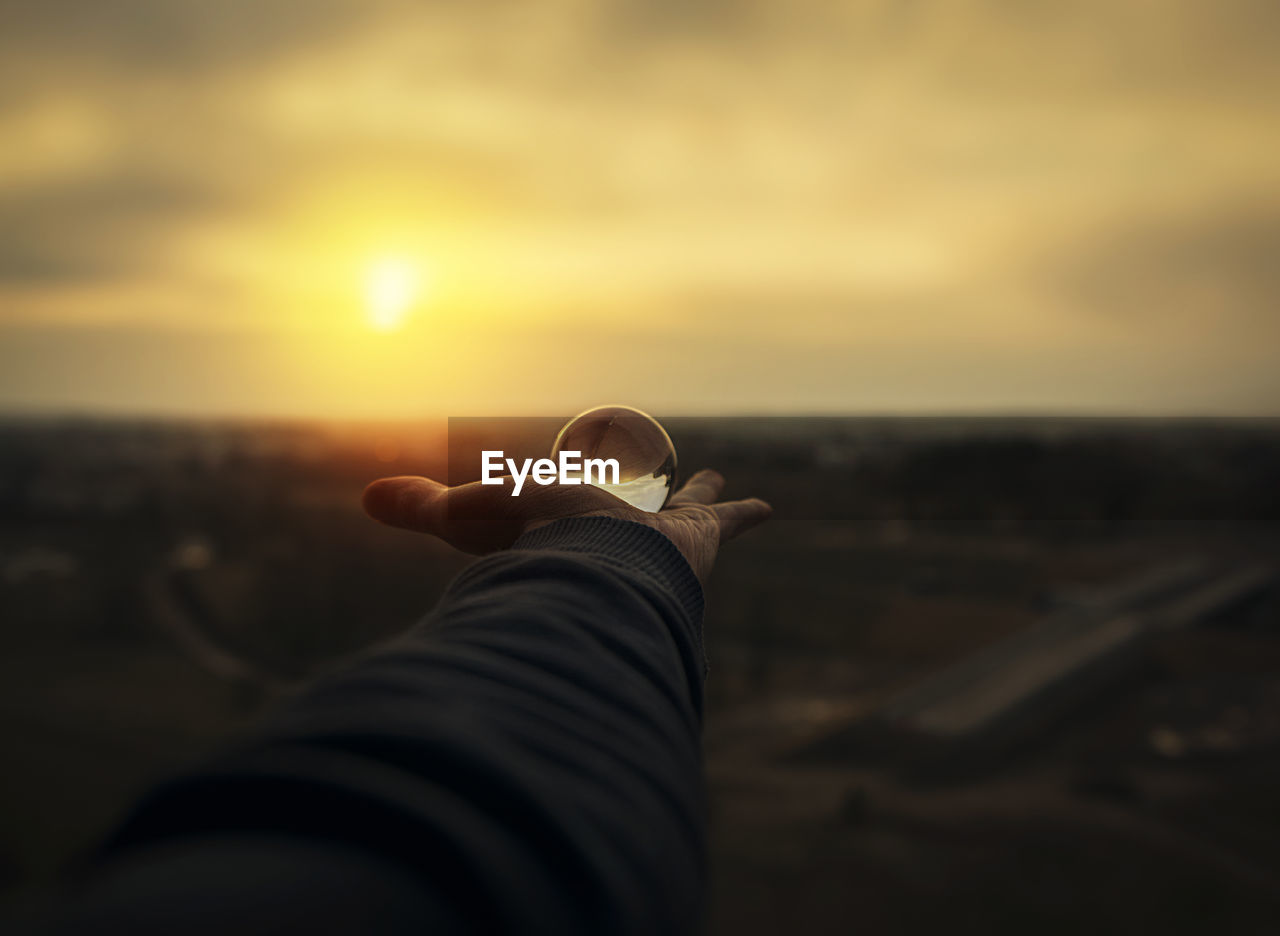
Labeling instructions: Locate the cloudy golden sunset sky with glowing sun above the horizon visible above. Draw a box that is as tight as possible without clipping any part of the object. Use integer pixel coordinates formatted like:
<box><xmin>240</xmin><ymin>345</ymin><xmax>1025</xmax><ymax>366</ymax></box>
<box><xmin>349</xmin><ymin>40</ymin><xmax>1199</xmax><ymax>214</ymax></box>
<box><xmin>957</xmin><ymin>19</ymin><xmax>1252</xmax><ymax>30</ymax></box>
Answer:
<box><xmin>0</xmin><ymin>0</ymin><xmax>1280</xmax><ymax>417</ymax></box>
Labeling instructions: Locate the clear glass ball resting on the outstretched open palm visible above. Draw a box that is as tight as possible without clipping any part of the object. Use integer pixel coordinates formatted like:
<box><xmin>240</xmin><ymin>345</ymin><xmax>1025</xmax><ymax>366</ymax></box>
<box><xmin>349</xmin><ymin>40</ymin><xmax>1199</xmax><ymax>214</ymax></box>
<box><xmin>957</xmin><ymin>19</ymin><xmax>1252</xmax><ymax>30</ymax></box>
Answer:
<box><xmin>552</xmin><ymin>406</ymin><xmax>676</xmax><ymax>513</ymax></box>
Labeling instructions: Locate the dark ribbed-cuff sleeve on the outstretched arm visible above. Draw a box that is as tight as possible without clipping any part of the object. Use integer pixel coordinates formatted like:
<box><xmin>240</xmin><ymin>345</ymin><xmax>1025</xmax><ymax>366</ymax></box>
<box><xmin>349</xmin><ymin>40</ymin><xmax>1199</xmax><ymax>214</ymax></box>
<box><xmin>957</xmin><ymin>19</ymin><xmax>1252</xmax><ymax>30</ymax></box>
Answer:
<box><xmin>40</xmin><ymin>517</ymin><xmax>705</xmax><ymax>933</ymax></box>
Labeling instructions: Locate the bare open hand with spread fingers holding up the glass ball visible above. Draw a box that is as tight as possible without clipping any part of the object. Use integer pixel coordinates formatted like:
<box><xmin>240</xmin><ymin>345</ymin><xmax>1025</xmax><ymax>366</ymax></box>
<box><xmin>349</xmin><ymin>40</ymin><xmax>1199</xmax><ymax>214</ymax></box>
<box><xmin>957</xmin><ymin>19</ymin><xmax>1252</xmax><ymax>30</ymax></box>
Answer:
<box><xmin>365</xmin><ymin>471</ymin><xmax>773</xmax><ymax>581</ymax></box>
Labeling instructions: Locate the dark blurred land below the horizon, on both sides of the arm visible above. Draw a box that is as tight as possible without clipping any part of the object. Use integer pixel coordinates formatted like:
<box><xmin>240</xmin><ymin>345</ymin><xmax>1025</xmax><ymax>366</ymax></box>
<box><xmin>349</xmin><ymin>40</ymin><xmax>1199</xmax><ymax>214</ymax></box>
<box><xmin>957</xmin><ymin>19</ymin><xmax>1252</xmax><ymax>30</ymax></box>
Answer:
<box><xmin>0</xmin><ymin>419</ymin><xmax>1280</xmax><ymax>933</ymax></box>
